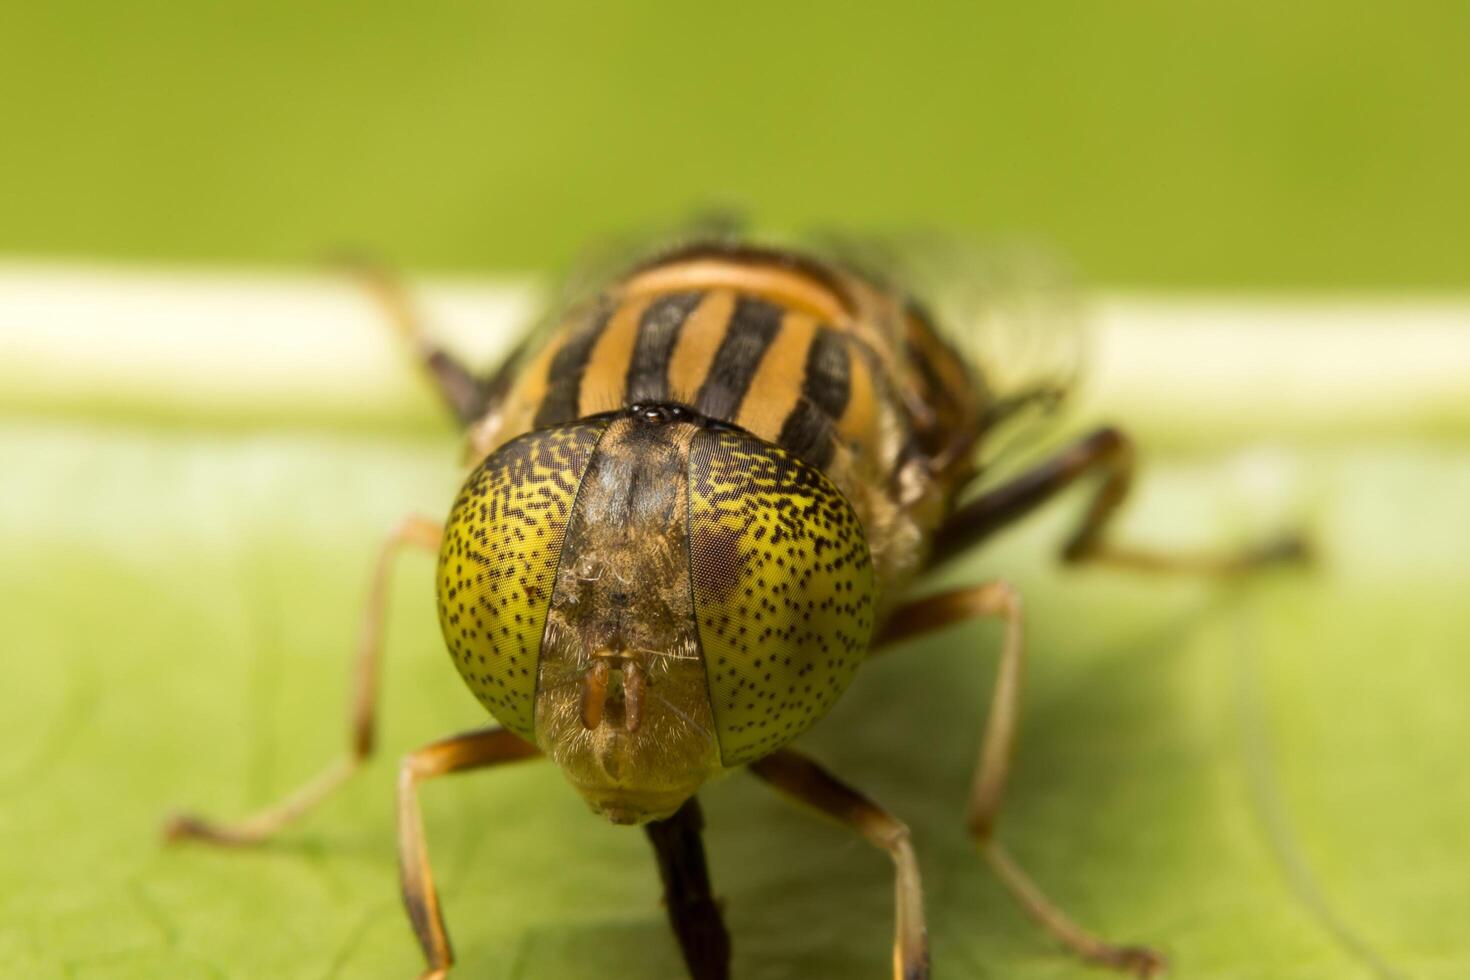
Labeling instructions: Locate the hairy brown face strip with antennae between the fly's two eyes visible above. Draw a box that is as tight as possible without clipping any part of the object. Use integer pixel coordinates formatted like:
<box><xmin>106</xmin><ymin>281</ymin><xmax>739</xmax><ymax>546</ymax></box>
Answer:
<box><xmin>537</xmin><ymin>416</ymin><xmax>722</xmax><ymax>823</ymax></box>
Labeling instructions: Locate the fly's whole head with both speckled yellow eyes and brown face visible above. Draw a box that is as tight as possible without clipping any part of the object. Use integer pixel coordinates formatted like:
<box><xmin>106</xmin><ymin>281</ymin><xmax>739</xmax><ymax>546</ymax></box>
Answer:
<box><xmin>440</xmin><ymin>408</ymin><xmax>875</xmax><ymax>823</ymax></box>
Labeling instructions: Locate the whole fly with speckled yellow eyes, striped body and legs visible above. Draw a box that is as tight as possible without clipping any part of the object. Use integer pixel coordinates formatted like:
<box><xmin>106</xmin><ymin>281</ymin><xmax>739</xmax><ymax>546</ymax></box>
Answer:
<box><xmin>168</xmin><ymin>232</ymin><xmax>1302</xmax><ymax>980</ymax></box>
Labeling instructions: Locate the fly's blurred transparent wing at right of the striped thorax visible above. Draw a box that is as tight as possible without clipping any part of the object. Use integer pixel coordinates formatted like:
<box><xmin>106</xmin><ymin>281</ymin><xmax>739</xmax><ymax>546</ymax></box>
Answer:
<box><xmin>823</xmin><ymin>234</ymin><xmax>1092</xmax><ymax>479</ymax></box>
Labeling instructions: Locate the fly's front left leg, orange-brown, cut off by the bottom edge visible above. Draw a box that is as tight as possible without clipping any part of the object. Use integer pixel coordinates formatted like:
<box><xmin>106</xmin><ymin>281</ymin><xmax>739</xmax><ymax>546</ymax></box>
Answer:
<box><xmin>398</xmin><ymin>729</ymin><xmax>539</xmax><ymax>980</ymax></box>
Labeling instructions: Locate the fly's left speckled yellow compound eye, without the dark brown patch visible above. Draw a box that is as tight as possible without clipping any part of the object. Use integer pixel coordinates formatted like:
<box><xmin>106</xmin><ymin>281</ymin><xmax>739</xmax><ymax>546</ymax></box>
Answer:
<box><xmin>438</xmin><ymin>423</ymin><xmax>606</xmax><ymax>742</ymax></box>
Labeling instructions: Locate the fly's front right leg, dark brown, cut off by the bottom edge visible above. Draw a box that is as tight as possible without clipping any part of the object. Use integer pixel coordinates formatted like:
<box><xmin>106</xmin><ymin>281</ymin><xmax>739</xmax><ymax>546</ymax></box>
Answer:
<box><xmin>750</xmin><ymin>749</ymin><xmax>929</xmax><ymax>980</ymax></box>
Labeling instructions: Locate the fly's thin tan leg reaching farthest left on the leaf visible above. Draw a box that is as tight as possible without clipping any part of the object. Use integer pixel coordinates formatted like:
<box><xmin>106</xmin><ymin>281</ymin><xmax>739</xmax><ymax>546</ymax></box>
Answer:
<box><xmin>163</xmin><ymin>517</ymin><xmax>442</xmax><ymax>845</ymax></box>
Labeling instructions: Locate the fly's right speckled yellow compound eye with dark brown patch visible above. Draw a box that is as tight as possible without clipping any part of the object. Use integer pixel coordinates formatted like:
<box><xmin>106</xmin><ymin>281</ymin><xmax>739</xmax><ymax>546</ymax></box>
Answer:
<box><xmin>689</xmin><ymin>429</ymin><xmax>876</xmax><ymax>765</ymax></box>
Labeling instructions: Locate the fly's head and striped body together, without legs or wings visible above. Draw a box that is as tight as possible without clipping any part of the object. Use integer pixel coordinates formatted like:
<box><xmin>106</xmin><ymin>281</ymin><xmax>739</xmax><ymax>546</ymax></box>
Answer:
<box><xmin>440</xmin><ymin>245</ymin><xmax>982</xmax><ymax>823</ymax></box>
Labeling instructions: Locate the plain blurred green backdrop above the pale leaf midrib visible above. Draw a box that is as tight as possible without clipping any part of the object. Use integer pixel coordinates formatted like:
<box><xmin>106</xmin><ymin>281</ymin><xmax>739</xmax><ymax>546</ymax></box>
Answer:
<box><xmin>0</xmin><ymin>0</ymin><xmax>1470</xmax><ymax>288</ymax></box>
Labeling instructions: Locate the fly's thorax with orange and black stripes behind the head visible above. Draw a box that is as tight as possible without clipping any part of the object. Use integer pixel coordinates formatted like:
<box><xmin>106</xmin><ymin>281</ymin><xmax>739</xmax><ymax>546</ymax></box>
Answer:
<box><xmin>469</xmin><ymin>247</ymin><xmax>980</xmax><ymax>597</ymax></box>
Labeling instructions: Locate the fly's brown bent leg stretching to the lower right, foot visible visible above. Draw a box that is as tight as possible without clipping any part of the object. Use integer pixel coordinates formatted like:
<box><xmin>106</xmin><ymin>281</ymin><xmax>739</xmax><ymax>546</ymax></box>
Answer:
<box><xmin>875</xmin><ymin>582</ymin><xmax>1164</xmax><ymax>977</ymax></box>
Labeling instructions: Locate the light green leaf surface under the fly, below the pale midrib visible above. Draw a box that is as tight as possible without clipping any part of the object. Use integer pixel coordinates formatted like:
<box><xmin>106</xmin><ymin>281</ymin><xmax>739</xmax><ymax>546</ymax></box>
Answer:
<box><xmin>0</xmin><ymin>408</ymin><xmax>1470</xmax><ymax>980</ymax></box>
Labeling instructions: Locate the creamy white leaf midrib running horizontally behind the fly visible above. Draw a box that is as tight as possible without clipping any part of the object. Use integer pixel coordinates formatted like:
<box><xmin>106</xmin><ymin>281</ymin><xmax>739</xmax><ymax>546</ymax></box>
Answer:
<box><xmin>0</xmin><ymin>262</ymin><xmax>1470</xmax><ymax>435</ymax></box>
